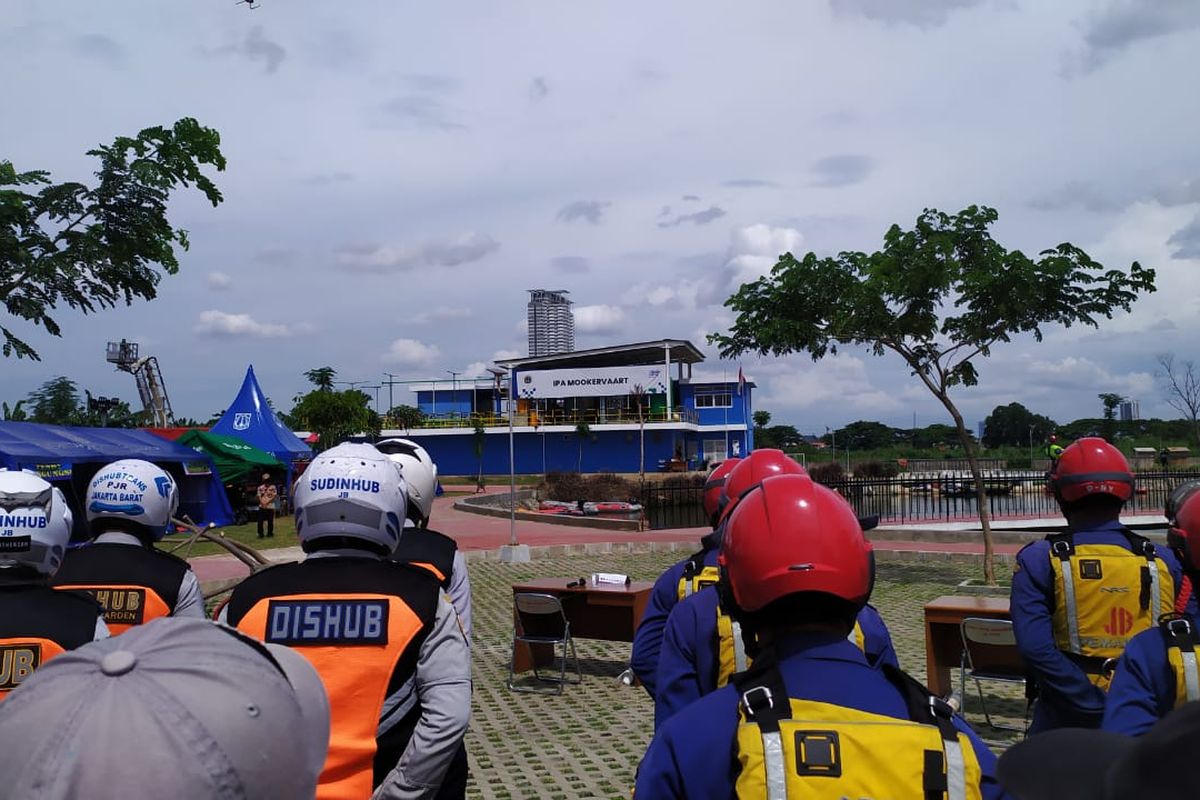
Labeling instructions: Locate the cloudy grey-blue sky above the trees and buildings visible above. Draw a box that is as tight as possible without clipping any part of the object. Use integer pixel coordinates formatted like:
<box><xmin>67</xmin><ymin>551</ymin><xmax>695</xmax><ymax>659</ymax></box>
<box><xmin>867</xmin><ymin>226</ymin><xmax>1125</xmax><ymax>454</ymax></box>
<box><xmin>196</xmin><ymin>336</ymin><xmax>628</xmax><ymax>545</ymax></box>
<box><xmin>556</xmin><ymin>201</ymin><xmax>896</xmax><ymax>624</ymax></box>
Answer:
<box><xmin>0</xmin><ymin>0</ymin><xmax>1200</xmax><ymax>431</ymax></box>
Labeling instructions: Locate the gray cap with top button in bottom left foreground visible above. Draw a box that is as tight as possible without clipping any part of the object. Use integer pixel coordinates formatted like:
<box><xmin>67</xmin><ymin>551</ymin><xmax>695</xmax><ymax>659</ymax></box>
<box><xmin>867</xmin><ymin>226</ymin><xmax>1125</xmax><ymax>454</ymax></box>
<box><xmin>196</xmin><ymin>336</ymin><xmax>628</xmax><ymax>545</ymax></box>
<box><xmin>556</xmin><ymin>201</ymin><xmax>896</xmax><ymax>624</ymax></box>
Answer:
<box><xmin>0</xmin><ymin>618</ymin><xmax>329</xmax><ymax>800</ymax></box>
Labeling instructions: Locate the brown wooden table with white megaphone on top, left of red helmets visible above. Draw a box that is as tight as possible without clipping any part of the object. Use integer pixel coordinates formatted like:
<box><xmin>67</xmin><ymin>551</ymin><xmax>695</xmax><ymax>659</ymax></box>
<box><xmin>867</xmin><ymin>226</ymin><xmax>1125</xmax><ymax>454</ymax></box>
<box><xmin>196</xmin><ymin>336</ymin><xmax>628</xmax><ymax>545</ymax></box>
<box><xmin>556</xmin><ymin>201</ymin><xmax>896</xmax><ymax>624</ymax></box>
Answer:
<box><xmin>512</xmin><ymin>578</ymin><xmax>654</xmax><ymax>672</ymax></box>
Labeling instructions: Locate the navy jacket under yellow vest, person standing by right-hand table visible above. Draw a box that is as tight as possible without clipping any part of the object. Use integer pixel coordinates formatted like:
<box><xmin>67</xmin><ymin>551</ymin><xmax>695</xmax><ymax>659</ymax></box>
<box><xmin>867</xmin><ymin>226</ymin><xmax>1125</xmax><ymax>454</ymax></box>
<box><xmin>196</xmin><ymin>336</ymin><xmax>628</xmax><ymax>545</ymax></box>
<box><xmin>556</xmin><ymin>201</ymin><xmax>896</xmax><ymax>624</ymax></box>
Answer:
<box><xmin>1010</xmin><ymin>522</ymin><xmax>1183</xmax><ymax>733</ymax></box>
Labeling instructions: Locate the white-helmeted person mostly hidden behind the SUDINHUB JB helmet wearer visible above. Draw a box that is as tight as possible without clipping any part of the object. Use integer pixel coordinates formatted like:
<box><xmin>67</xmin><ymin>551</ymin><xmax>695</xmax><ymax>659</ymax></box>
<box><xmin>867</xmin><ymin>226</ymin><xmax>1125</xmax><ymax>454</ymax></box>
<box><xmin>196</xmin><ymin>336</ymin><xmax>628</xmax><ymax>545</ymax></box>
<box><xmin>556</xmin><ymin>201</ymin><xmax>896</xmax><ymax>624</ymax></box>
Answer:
<box><xmin>376</xmin><ymin>439</ymin><xmax>472</xmax><ymax>800</ymax></box>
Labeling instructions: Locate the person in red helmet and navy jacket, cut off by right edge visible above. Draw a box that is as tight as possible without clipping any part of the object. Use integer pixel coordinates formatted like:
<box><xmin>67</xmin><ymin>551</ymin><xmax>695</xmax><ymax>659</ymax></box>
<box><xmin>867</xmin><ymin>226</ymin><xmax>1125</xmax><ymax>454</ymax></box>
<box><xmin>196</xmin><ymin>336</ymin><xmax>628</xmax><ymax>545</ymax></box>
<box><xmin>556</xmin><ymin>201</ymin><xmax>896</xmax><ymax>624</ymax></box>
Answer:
<box><xmin>1100</xmin><ymin>481</ymin><xmax>1200</xmax><ymax>736</ymax></box>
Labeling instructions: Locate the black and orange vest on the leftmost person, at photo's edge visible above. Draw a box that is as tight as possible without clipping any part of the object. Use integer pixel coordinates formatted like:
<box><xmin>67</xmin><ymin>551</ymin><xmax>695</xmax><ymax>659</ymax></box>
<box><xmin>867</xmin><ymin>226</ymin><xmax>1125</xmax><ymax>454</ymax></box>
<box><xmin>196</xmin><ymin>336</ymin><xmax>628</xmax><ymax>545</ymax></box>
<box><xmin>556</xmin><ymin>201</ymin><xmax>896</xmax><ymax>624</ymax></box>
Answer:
<box><xmin>0</xmin><ymin>584</ymin><xmax>100</xmax><ymax>700</ymax></box>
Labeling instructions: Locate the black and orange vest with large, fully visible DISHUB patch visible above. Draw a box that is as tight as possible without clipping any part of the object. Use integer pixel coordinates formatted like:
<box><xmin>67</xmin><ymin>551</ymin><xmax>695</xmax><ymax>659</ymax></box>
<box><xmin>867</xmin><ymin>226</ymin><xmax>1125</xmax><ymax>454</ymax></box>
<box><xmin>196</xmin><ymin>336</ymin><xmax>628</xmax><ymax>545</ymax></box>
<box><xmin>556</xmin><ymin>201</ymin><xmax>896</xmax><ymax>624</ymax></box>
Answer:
<box><xmin>227</xmin><ymin>557</ymin><xmax>440</xmax><ymax>800</ymax></box>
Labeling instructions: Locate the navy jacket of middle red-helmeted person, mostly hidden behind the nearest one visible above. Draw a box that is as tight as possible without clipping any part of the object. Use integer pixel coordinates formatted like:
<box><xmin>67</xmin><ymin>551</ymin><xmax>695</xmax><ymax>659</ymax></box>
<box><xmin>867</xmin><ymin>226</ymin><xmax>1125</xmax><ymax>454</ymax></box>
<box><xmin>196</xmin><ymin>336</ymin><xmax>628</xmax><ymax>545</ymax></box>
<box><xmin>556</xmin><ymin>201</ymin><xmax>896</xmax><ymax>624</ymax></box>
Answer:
<box><xmin>654</xmin><ymin>587</ymin><xmax>900</xmax><ymax>729</ymax></box>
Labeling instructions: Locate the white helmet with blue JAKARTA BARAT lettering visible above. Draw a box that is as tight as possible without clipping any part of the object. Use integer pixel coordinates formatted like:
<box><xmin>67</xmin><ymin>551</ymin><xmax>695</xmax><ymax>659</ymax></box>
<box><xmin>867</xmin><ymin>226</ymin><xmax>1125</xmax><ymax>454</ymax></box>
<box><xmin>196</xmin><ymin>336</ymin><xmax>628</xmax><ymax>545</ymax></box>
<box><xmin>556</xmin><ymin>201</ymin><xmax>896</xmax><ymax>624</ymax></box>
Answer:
<box><xmin>84</xmin><ymin>458</ymin><xmax>179</xmax><ymax>541</ymax></box>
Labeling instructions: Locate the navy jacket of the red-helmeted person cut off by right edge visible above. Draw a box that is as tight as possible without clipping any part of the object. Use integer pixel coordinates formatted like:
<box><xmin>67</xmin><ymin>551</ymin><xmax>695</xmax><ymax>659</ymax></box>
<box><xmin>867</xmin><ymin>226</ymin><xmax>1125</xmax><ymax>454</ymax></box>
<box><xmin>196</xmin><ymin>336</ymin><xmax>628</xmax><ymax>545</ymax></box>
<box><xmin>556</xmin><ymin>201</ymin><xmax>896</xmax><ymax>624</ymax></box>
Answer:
<box><xmin>1100</xmin><ymin>615</ymin><xmax>1200</xmax><ymax>736</ymax></box>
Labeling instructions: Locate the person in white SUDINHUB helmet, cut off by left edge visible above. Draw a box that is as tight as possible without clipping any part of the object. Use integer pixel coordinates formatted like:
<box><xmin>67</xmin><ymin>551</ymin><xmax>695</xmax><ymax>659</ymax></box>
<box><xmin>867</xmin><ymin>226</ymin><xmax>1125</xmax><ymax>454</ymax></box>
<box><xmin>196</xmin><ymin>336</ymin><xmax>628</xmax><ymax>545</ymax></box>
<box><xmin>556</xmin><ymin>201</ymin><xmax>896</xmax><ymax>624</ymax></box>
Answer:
<box><xmin>0</xmin><ymin>469</ymin><xmax>108</xmax><ymax>700</ymax></box>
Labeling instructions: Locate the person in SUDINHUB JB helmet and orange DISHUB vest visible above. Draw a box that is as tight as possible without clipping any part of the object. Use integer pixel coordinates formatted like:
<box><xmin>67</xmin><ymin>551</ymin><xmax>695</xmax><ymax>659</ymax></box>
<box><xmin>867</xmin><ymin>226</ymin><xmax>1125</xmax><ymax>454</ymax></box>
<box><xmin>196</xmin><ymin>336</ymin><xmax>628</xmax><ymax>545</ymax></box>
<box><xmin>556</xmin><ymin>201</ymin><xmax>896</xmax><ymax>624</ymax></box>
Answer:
<box><xmin>222</xmin><ymin>444</ymin><xmax>470</xmax><ymax>800</ymax></box>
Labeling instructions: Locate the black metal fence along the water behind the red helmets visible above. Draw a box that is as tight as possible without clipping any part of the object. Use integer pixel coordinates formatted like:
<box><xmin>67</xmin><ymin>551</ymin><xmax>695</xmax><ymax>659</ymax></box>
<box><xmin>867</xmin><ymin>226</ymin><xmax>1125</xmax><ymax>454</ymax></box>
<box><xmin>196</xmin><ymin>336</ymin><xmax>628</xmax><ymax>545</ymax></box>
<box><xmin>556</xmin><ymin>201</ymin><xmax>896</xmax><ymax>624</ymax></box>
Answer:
<box><xmin>642</xmin><ymin>470</ymin><xmax>1200</xmax><ymax>529</ymax></box>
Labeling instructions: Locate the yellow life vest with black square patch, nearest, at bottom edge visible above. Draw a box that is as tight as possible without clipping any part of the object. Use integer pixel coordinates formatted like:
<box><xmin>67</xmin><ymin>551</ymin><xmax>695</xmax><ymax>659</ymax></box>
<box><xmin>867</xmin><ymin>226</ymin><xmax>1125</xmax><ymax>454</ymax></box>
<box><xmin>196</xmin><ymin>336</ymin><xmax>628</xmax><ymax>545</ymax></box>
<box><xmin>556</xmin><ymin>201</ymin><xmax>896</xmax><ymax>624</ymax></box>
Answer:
<box><xmin>734</xmin><ymin>666</ymin><xmax>983</xmax><ymax>800</ymax></box>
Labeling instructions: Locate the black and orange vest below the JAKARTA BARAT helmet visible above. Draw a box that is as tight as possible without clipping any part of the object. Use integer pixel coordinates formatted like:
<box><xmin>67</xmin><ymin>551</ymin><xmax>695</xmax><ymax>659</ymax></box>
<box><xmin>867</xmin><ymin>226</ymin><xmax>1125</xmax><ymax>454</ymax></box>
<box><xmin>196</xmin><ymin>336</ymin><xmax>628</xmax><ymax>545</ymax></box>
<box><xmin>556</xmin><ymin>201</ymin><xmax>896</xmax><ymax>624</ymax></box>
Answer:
<box><xmin>54</xmin><ymin>542</ymin><xmax>183</xmax><ymax>636</ymax></box>
